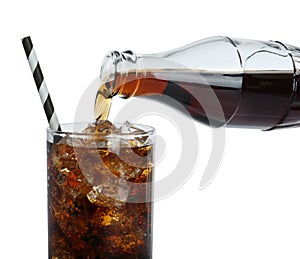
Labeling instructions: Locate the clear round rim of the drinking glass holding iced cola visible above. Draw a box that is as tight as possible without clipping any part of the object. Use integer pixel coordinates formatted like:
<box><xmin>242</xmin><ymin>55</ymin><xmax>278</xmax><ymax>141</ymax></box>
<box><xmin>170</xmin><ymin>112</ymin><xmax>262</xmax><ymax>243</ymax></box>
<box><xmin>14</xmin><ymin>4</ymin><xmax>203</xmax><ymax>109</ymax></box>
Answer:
<box><xmin>46</xmin><ymin>122</ymin><xmax>155</xmax><ymax>139</ymax></box>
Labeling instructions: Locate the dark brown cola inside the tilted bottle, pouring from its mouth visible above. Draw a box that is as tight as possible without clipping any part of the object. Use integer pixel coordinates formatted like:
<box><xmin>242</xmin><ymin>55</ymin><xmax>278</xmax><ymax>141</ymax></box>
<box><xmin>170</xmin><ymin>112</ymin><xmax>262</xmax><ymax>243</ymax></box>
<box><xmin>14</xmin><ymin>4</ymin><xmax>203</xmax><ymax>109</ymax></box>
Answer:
<box><xmin>96</xmin><ymin>70</ymin><xmax>294</xmax><ymax>129</ymax></box>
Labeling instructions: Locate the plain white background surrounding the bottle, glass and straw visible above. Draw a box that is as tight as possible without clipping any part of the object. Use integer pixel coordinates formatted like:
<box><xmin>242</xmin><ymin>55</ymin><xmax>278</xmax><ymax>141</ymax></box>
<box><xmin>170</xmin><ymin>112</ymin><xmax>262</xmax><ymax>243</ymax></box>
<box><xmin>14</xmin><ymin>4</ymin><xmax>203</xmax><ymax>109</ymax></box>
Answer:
<box><xmin>0</xmin><ymin>0</ymin><xmax>300</xmax><ymax>259</ymax></box>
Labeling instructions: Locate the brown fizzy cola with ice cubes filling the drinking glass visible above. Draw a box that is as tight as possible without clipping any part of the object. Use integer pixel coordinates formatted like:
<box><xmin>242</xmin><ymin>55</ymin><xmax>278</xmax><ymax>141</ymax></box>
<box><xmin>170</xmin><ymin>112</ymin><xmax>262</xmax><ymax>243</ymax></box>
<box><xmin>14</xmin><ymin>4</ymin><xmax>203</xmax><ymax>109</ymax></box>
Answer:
<box><xmin>48</xmin><ymin>129</ymin><xmax>153</xmax><ymax>259</ymax></box>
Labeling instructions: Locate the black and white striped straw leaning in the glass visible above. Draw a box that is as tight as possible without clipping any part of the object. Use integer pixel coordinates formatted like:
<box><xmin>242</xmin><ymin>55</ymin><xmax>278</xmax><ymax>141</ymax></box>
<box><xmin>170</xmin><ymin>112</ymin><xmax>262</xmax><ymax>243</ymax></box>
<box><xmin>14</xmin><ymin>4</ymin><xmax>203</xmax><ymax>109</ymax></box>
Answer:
<box><xmin>22</xmin><ymin>36</ymin><xmax>61</xmax><ymax>131</ymax></box>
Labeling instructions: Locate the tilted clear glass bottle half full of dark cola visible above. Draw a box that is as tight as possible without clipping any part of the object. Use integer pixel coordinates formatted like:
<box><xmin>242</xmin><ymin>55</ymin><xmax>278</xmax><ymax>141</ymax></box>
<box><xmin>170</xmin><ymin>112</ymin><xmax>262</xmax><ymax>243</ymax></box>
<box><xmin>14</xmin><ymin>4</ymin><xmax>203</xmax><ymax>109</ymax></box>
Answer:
<box><xmin>99</xmin><ymin>37</ymin><xmax>300</xmax><ymax>130</ymax></box>
